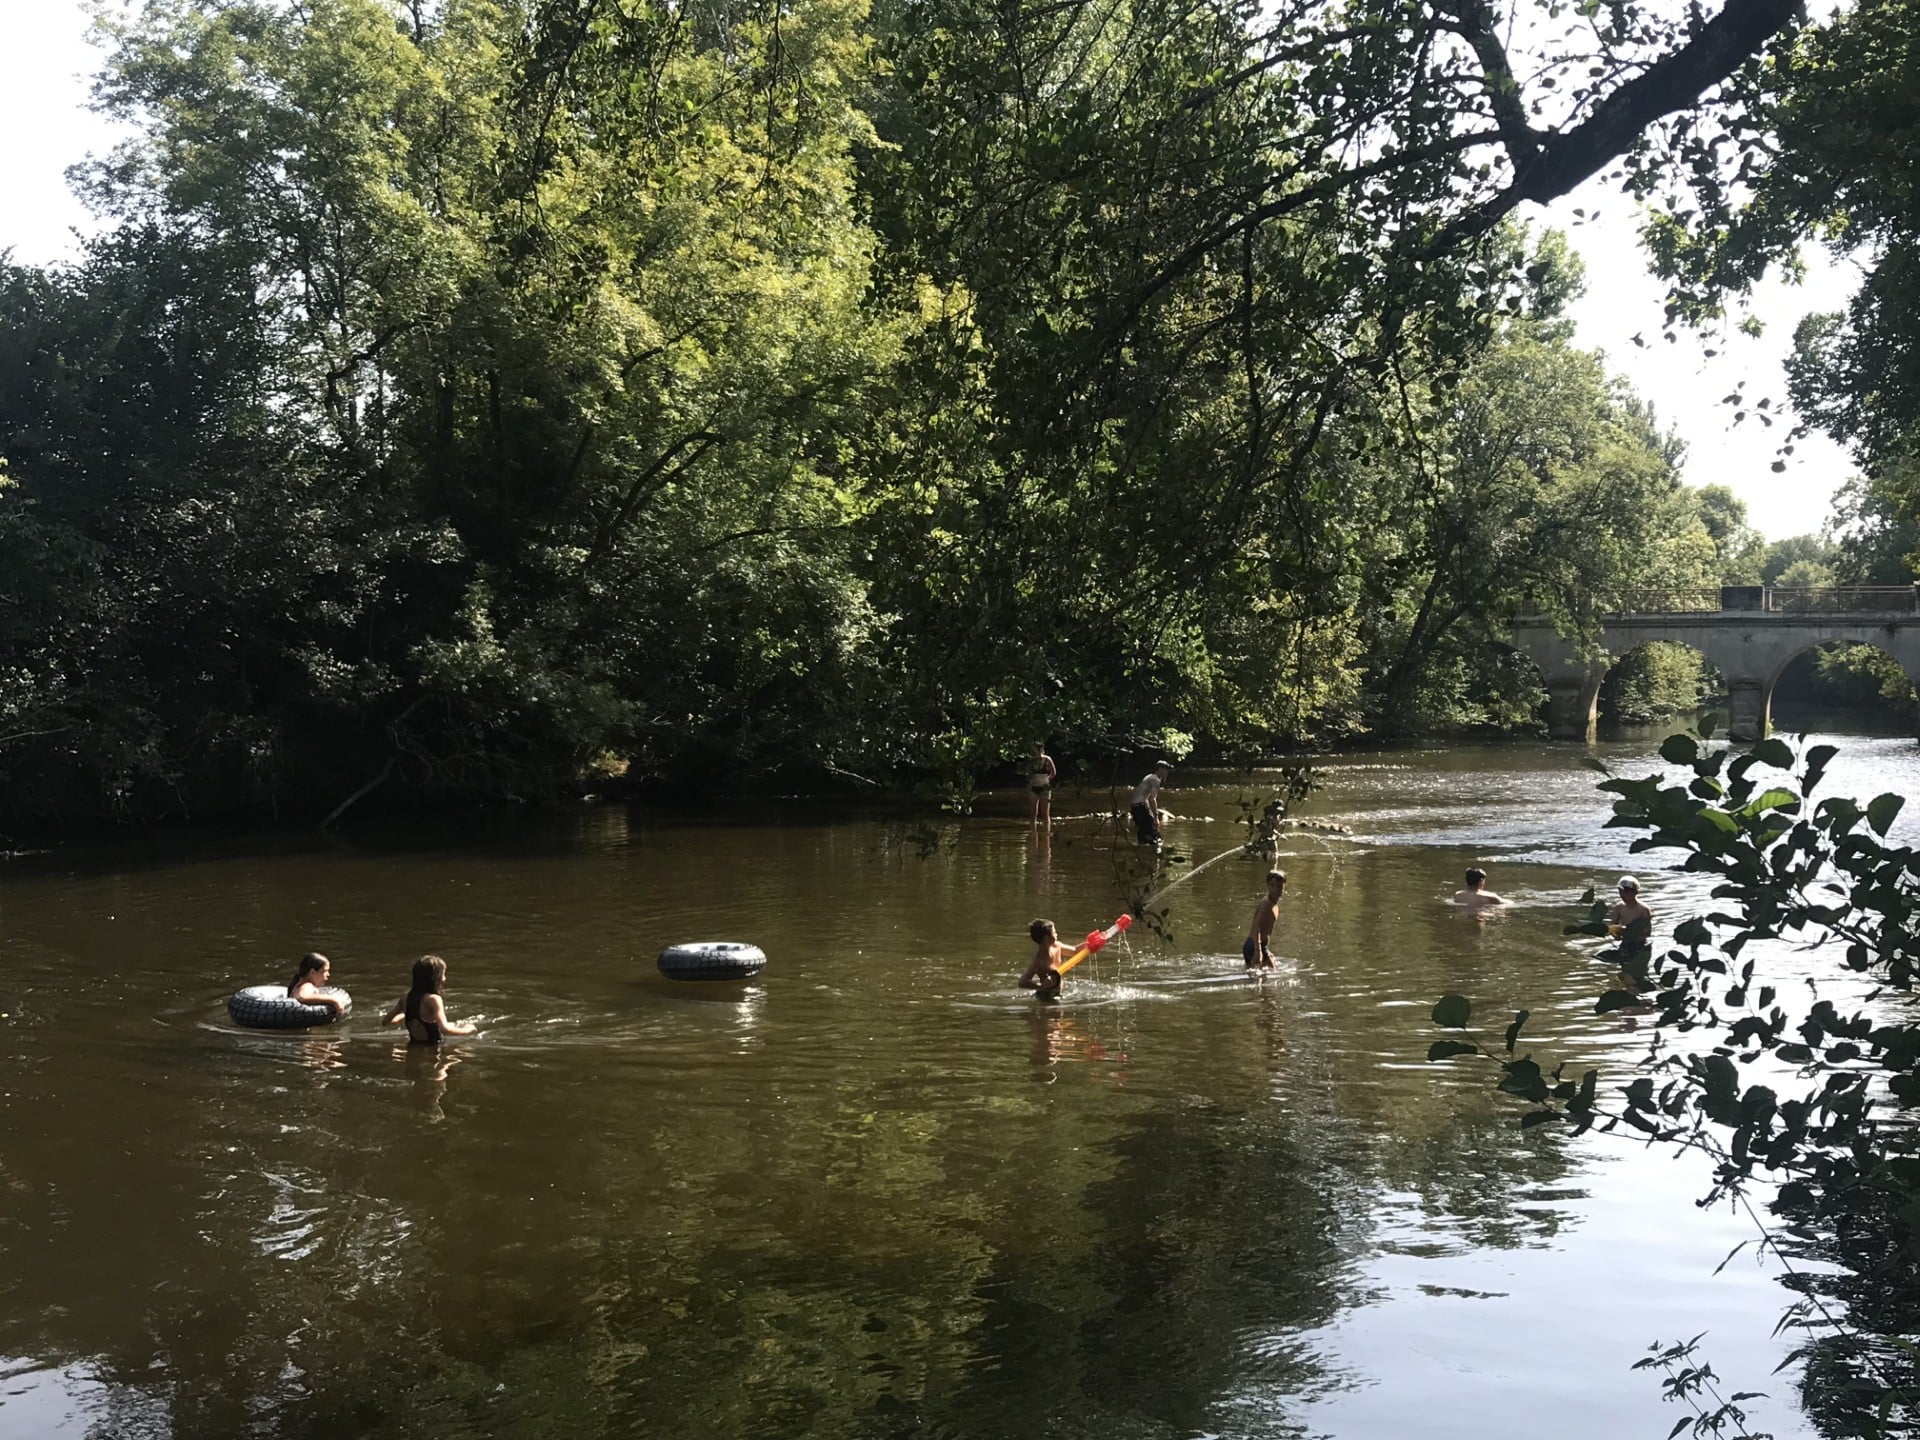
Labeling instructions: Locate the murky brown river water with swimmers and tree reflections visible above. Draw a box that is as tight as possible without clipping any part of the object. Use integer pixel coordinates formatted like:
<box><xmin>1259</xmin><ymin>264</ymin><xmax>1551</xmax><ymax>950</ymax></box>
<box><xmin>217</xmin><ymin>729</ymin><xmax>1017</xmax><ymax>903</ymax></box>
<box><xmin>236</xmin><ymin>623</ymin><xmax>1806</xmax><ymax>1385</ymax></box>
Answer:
<box><xmin>0</xmin><ymin>737</ymin><xmax>1920</xmax><ymax>1440</ymax></box>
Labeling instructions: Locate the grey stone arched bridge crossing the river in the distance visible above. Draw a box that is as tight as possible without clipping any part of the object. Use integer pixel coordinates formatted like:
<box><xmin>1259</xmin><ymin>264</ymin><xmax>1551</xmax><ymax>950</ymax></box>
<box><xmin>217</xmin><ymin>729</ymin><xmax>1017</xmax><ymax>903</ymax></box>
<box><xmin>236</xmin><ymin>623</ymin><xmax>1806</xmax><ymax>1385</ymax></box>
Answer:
<box><xmin>1513</xmin><ymin>591</ymin><xmax>1920</xmax><ymax>741</ymax></box>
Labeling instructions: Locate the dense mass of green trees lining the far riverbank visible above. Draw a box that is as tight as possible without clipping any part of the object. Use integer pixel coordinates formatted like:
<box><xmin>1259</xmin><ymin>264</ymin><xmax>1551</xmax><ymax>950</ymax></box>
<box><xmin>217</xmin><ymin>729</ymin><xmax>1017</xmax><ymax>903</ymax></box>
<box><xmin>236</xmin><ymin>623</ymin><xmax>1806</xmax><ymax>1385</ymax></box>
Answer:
<box><xmin>0</xmin><ymin>0</ymin><xmax>1873</xmax><ymax>824</ymax></box>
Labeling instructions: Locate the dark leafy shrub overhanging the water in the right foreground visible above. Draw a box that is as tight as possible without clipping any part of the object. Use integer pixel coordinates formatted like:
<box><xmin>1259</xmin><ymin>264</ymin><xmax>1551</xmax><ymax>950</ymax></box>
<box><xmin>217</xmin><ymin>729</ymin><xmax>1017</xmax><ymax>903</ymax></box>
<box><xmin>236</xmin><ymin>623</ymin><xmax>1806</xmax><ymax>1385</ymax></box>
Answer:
<box><xmin>1428</xmin><ymin>735</ymin><xmax>1920</xmax><ymax>1436</ymax></box>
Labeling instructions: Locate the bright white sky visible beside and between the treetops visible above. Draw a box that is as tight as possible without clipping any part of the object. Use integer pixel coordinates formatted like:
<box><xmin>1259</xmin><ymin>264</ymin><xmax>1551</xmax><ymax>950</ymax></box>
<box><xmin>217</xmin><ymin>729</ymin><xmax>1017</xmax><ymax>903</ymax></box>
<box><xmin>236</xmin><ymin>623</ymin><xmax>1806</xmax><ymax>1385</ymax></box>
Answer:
<box><xmin>0</xmin><ymin>0</ymin><xmax>1853</xmax><ymax>540</ymax></box>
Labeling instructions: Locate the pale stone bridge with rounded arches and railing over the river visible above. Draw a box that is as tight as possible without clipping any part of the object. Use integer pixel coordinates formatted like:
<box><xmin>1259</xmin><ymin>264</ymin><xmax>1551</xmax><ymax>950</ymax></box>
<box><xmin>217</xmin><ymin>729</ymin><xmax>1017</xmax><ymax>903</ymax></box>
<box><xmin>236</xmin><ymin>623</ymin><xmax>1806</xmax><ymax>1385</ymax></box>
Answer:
<box><xmin>1513</xmin><ymin>586</ymin><xmax>1920</xmax><ymax>741</ymax></box>
